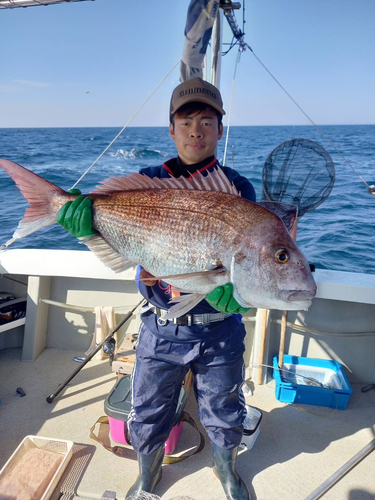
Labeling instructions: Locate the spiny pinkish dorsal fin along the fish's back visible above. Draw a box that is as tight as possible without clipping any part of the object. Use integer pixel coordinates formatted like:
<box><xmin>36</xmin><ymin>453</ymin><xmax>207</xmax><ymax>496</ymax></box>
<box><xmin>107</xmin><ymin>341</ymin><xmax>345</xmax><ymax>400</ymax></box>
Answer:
<box><xmin>91</xmin><ymin>168</ymin><xmax>240</xmax><ymax>196</ymax></box>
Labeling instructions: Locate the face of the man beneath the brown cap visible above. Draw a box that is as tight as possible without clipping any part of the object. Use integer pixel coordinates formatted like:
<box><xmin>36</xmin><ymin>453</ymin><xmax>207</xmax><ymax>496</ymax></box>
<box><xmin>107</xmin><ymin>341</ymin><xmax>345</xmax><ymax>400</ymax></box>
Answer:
<box><xmin>169</xmin><ymin>109</ymin><xmax>223</xmax><ymax>165</ymax></box>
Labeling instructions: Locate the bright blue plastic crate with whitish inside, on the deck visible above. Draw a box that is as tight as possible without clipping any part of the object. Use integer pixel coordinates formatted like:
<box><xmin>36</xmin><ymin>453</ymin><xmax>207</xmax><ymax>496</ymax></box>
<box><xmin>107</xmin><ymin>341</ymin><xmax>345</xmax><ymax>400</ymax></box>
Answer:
<box><xmin>273</xmin><ymin>355</ymin><xmax>353</xmax><ymax>410</ymax></box>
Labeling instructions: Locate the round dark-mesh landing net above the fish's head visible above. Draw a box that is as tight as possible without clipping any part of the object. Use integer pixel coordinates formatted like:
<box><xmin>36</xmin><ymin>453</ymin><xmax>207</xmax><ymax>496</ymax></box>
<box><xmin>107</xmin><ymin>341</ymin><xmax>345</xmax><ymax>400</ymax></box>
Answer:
<box><xmin>262</xmin><ymin>139</ymin><xmax>335</xmax><ymax>217</ymax></box>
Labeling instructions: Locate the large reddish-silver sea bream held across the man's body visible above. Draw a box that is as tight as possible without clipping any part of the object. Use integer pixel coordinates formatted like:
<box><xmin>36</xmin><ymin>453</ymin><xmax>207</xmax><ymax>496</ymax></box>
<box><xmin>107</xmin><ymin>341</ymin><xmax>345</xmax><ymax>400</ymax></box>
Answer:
<box><xmin>0</xmin><ymin>160</ymin><xmax>316</xmax><ymax>317</ymax></box>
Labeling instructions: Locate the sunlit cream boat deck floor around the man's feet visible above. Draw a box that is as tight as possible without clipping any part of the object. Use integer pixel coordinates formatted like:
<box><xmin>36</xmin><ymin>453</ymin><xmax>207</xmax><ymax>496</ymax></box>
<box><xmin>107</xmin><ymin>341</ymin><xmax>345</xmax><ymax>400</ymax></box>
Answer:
<box><xmin>0</xmin><ymin>348</ymin><xmax>375</xmax><ymax>500</ymax></box>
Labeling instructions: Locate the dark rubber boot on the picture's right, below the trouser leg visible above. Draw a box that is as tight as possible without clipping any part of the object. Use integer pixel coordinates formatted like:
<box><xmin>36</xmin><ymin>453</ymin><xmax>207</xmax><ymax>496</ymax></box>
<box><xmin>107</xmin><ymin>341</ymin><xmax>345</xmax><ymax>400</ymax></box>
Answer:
<box><xmin>211</xmin><ymin>443</ymin><xmax>250</xmax><ymax>500</ymax></box>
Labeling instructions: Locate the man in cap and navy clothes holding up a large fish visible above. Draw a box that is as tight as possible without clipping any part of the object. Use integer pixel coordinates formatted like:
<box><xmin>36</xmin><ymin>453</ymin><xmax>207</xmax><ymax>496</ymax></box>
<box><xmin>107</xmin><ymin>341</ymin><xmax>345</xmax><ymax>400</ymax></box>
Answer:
<box><xmin>58</xmin><ymin>78</ymin><xmax>255</xmax><ymax>500</ymax></box>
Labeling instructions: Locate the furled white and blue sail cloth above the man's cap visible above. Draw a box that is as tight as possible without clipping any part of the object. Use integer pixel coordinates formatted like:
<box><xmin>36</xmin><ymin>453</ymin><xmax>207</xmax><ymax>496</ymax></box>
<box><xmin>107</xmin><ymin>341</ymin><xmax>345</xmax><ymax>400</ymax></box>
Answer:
<box><xmin>180</xmin><ymin>0</ymin><xmax>220</xmax><ymax>82</ymax></box>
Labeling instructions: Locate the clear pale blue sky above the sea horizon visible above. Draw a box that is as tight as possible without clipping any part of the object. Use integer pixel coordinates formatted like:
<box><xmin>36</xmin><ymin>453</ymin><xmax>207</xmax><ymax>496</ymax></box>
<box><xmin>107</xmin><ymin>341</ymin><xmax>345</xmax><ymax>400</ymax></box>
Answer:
<box><xmin>0</xmin><ymin>0</ymin><xmax>375</xmax><ymax>127</ymax></box>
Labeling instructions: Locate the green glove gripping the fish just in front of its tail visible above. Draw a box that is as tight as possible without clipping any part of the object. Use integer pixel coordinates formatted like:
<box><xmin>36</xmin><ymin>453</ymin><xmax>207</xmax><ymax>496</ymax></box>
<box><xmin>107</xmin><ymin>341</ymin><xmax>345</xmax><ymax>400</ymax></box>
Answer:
<box><xmin>57</xmin><ymin>189</ymin><xmax>96</xmax><ymax>238</ymax></box>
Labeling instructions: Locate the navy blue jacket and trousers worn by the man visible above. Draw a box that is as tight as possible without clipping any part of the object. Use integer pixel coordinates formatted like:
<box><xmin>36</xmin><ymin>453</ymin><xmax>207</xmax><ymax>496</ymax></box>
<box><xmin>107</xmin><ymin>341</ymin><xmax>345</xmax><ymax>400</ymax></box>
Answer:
<box><xmin>128</xmin><ymin>157</ymin><xmax>255</xmax><ymax>454</ymax></box>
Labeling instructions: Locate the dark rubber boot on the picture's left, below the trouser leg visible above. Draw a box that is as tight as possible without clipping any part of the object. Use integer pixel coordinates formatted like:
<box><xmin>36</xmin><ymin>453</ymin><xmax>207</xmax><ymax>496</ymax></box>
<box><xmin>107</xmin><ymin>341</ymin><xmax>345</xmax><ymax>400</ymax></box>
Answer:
<box><xmin>125</xmin><ymin>446</ymin><xmax>164</xmax><ymax>500</ymax></box>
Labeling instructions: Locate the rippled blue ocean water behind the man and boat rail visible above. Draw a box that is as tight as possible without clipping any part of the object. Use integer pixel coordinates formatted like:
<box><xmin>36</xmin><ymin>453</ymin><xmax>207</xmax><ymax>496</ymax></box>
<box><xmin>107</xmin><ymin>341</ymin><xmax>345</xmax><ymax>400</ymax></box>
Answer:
<box><xmin>0</xmin><ymin>125</ymin><xmax>375</xmax><ymax>274</ymax></box>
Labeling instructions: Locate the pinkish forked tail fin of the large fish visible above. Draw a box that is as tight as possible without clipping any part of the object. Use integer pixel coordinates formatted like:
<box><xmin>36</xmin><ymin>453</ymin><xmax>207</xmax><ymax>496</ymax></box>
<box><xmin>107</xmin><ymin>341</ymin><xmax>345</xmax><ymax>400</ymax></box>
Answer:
<box><xmin>0</xmin><ymin>159</ymin><xmax>67</xmax><ymax>239</ymax></box>
